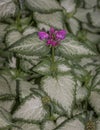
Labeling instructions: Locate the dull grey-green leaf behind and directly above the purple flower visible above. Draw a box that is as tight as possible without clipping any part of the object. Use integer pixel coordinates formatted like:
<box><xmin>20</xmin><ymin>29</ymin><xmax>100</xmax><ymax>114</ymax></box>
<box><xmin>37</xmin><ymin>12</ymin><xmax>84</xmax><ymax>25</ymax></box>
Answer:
<box><xmin>34</xmin><ymin>11</ymin><xmax>64</xmax><ymax>29</ymax></box>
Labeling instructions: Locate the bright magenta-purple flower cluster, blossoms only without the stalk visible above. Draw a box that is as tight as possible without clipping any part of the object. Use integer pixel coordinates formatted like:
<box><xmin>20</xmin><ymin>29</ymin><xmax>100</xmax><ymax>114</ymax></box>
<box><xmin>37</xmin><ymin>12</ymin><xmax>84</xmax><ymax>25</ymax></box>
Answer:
<box><xmin>38</xmin><ymin>27</ymin><xmax>67</xmax><ymax>46</ymax></box>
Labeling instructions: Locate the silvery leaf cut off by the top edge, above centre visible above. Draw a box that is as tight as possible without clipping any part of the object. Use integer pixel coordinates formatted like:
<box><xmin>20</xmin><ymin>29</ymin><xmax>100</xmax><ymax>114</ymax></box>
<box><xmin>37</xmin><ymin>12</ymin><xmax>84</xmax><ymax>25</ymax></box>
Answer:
<box><xmin>25</xmin><ymin>0</ymin><xmax>62</xmax><ymax>13</ymax></box>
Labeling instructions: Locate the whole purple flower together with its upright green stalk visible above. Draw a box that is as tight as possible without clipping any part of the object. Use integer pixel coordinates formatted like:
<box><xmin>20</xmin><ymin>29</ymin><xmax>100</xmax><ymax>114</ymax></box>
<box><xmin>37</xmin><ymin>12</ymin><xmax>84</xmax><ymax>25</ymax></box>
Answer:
<box><xmin>38</xmin><ymin>27</ymin><xmax>67</xmax><ymax>77</ymax></box>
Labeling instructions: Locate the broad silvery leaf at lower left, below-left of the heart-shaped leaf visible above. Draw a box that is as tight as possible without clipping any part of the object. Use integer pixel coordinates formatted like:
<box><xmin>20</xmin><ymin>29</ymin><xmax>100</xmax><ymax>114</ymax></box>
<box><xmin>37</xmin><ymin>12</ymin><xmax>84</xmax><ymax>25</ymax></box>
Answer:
<box><xmin>13</xmin><ymin>96</ymin><xmax>46</xmax><ymax>121</ymax></box>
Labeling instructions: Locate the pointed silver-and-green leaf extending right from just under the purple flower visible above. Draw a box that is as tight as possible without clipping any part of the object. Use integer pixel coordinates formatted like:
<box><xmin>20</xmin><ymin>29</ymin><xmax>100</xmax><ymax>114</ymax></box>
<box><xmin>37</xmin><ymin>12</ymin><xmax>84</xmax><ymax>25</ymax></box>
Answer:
<box><xmin>57</xmin><ymin>36</ymin><xmax>96</xmax><ymax>57</ymax></box>
